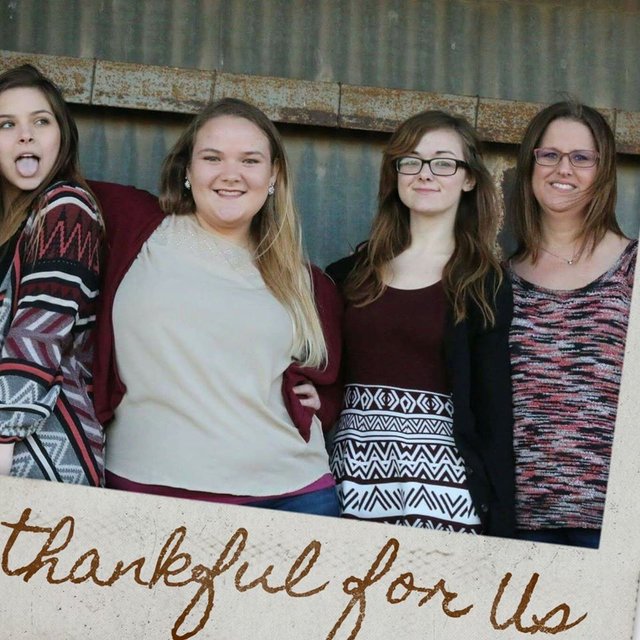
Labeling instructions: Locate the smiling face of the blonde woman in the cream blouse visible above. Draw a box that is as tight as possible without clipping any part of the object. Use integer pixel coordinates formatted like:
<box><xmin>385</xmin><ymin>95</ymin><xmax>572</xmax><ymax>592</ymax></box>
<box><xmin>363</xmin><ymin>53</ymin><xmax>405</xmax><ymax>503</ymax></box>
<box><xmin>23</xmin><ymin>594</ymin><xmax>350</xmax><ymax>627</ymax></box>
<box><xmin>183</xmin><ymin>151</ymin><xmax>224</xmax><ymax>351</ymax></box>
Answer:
<box><xmin>187</xmin><ymin>116</ymin><xmax>277</xmax><ymax>244</ymax></box>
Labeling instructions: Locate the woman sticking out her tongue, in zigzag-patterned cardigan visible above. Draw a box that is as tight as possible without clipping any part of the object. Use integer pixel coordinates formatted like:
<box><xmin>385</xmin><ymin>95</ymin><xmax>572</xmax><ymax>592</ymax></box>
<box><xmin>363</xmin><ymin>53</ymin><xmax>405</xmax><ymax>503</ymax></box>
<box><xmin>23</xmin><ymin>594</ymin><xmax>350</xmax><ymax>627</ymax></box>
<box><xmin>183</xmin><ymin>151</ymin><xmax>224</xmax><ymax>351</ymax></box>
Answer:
<box><xmin>0</xmin><ymin>65</ymin><xmax>104</xmax><ymax>486</ymax></box>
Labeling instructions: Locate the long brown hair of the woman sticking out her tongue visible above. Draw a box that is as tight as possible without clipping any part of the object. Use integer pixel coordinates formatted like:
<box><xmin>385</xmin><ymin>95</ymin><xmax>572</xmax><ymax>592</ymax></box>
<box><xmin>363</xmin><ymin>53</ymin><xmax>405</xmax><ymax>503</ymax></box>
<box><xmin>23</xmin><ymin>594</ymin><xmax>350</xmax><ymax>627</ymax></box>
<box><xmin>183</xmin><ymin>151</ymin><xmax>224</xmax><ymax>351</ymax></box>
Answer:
<box><xmin>0</xmin><ymin>64</ymin><xmax>98</xmax><ymax>246</ymax></box>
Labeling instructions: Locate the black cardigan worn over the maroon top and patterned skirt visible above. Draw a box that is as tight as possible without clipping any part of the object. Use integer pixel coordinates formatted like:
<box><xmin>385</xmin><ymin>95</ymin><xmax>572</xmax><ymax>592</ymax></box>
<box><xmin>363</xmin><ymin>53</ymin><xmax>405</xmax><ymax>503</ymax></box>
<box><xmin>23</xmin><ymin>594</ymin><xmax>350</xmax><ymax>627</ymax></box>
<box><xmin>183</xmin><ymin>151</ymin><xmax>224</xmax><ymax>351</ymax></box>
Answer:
<box><xmin>326</xmin><ymin>254</ymin><xmax>515</xmax><ymax>537</ymax></box>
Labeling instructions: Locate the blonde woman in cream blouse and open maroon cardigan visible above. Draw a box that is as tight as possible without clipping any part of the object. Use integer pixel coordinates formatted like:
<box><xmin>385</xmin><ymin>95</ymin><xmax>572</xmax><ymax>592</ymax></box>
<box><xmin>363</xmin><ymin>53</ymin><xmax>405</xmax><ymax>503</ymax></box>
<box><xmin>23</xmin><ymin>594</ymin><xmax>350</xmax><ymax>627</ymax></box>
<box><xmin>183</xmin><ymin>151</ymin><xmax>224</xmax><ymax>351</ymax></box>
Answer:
<box><xmin>96</xmin><ymin>99</ymin><xmax>341</xmax><ymax>515</ymax></box>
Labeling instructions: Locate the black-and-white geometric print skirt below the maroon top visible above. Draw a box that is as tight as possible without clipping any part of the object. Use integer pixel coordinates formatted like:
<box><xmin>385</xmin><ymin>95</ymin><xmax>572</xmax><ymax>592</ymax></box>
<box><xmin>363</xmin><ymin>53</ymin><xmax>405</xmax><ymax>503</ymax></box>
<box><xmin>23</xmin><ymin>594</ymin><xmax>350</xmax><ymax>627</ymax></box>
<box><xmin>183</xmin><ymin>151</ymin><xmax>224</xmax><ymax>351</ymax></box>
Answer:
<box><xmin>331</xmin><ymin>384</ymin><xmax>481</xmax><ymax>533</ymax></box>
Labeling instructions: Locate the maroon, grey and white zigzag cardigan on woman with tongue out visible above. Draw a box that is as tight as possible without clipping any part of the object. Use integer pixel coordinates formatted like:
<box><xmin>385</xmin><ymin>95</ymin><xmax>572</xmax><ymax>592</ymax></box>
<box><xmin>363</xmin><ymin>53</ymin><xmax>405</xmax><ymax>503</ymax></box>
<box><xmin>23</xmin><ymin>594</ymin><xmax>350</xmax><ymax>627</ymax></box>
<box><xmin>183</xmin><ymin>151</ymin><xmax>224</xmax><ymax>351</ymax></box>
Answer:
<box><xmin>0</xmin><ymin>183</ymin><xmax>104</xmax><ymax>486</ymax></box>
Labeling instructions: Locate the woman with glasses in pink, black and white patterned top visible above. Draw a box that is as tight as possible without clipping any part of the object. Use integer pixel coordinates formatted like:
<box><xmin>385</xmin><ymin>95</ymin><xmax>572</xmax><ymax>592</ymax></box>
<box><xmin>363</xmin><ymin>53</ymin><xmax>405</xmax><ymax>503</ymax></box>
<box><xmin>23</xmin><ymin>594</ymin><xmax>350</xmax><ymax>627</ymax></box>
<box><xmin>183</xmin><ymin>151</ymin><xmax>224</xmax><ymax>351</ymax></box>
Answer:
<box><xmin>510</xmin><ymin>102</ymin><xmax>637</xmax><ymax>547</ymax></box>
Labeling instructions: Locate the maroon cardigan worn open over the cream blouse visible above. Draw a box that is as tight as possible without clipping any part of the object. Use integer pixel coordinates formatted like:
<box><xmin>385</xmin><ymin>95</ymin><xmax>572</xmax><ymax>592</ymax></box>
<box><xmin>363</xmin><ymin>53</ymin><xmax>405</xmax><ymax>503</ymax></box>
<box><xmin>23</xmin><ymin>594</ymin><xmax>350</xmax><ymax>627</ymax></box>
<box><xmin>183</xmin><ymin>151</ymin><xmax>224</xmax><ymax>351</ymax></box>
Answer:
<box><xmin>89</xmin><ymin>181</ymin><xmax>342</xmax><ymax>442</ymax></box>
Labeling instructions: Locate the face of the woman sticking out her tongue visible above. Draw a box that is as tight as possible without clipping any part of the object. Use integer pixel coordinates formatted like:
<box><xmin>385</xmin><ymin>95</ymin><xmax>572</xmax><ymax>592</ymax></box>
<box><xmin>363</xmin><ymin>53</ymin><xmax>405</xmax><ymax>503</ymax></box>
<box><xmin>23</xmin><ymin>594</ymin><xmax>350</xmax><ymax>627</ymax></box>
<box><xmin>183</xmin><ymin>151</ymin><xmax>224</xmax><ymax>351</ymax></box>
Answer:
<box><xmin>0</xmin><ymin>87</ymin><xmax>60</xmax><ymax>209</ymax></box>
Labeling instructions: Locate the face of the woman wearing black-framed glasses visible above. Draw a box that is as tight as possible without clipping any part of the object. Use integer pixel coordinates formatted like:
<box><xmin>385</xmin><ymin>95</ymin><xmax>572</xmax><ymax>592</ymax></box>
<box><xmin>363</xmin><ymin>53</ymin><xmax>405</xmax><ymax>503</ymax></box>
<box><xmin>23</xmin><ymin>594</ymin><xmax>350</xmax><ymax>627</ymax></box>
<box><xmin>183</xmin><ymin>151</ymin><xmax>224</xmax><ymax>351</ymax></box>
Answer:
<box><xmin>398</xmin><ymin>129</ymin><xmax>474</xmax><ymax>219</ymax></box>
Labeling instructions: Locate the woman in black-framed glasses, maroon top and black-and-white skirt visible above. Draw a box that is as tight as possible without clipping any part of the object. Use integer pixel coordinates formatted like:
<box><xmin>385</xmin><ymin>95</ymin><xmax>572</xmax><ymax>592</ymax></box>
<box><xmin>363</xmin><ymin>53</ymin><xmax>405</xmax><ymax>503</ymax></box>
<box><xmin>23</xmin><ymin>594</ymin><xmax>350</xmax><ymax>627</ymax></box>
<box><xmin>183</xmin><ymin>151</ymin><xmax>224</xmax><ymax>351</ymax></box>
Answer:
<box><xmin>328</xmin><ymin>111</ymin><xmax>514</xmax><ymax>536</ymax></box>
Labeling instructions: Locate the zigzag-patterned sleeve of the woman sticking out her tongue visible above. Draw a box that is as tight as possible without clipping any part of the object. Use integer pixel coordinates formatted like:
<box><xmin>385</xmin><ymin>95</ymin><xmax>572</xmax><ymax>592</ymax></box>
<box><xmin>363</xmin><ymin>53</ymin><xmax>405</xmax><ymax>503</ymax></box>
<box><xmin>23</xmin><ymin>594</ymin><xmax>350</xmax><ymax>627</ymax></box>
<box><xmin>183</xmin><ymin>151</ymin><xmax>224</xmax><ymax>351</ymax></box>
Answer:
<box><xmin>0</xmin><ymin>184</ymin><xmax>102</xmax><ymax>442</ymax></box>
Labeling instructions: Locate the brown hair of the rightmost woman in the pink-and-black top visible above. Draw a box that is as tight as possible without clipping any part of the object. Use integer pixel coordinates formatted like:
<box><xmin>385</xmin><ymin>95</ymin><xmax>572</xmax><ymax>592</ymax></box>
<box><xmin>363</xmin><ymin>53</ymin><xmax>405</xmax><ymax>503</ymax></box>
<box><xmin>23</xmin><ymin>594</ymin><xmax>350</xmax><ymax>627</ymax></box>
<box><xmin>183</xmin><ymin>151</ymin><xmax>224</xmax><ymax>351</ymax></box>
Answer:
<box><xmin>508</xmin><ymin>100</ymin><xmax>624</xmax><ymax>262</ymax></box>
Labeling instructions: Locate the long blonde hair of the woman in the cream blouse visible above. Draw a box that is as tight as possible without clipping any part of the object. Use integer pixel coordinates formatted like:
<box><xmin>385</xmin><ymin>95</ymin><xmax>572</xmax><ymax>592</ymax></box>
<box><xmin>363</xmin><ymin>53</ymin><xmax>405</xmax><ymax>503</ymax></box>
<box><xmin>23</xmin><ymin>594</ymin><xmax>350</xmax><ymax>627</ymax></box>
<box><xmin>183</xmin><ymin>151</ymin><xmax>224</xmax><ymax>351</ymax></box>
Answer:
<box><xmin>160</xmin><ymin>98</ymin><xmax>327</xmax><ymax>367</ymax></box>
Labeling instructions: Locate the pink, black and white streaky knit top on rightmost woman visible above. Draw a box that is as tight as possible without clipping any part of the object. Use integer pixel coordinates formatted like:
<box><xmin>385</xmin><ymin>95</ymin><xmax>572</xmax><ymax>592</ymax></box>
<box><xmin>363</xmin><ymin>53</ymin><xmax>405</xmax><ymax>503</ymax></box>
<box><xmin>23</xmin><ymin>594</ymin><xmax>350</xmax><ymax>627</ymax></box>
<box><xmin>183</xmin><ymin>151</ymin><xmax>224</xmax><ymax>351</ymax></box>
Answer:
<box><xmin>509</xmin><ymin>240</ymin><xmax>638</xmax><ymax>529</ymax></box>
